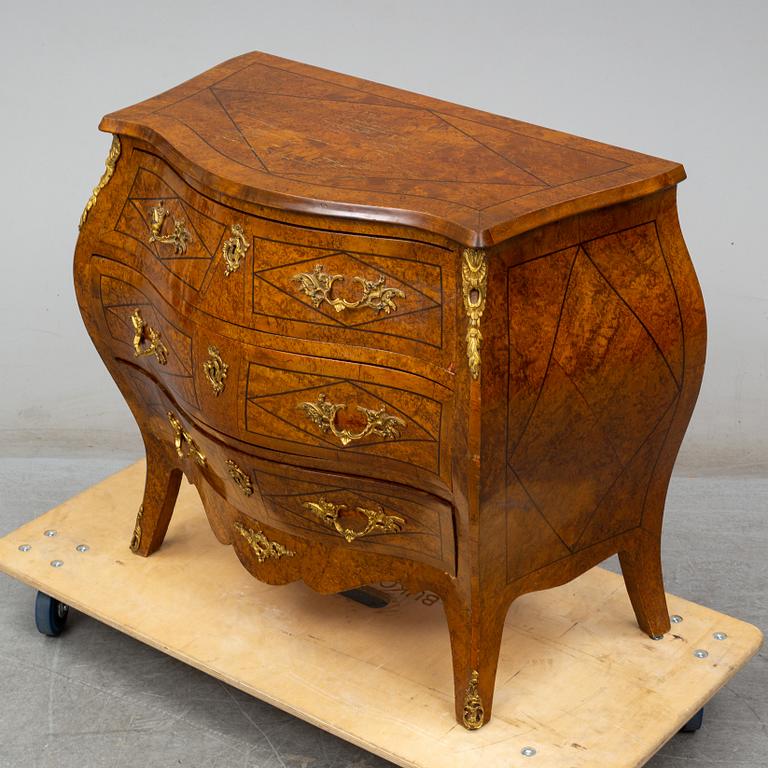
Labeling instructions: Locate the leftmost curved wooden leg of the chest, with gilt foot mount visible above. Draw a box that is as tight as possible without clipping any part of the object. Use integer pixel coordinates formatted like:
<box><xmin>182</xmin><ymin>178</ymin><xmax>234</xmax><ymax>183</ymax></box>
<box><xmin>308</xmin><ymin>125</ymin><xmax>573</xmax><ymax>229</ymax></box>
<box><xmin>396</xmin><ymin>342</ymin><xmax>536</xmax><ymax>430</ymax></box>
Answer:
<box><xmin>131</xmin><ymin>435</ymin><xmax>182</xmax><ymax>557</ymax></box>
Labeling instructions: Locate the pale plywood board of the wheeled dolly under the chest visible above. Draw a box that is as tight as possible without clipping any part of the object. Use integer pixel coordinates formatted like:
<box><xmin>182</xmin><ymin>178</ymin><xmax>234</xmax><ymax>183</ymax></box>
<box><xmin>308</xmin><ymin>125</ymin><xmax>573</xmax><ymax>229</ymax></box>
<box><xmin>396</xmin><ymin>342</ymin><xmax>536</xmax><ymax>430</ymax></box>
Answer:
<box><xmin>0</xmin><ymin>463</ymin><xmax>762</xmax><ymax>768</ymax></box>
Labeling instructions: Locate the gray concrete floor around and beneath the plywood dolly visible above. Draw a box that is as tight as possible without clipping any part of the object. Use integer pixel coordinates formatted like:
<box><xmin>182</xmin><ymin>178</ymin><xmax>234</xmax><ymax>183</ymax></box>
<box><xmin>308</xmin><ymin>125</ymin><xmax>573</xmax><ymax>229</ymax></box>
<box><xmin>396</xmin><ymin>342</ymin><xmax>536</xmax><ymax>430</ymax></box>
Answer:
<box><xmin>0</xmin><ymin>458</ymin><xmax>768</xmax><ymax>768</ymax></box>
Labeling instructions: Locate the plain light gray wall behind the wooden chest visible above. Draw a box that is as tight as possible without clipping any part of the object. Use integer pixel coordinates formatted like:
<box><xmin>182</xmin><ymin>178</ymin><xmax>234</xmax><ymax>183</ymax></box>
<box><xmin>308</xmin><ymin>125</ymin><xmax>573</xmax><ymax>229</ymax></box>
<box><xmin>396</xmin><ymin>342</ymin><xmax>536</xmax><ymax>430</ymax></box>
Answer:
<box><xmin>0</xmin><ymin>0</ymin><xmax>768</xmax><ymax>473</ymax></box>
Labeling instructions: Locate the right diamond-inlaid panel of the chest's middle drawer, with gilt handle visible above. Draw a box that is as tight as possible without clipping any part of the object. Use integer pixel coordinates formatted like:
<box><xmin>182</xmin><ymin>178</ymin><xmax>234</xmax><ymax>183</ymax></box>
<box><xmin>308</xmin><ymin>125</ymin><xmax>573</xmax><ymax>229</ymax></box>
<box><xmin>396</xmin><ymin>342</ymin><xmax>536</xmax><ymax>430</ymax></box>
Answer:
<box><xmin>237</xmin><ymin>350</ymin><xmax>451</xmax><ymax>478</ymax></box>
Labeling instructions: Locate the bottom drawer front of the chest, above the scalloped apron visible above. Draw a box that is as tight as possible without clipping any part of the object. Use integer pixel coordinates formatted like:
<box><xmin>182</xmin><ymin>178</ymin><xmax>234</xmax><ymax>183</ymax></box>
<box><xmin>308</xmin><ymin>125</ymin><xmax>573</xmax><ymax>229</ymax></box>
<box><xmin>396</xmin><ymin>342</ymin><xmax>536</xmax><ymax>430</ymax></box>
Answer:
<box><xmin>118</xmin><ymin>365</ymin><xmax>456</xmax><ymax>575</ymax></box>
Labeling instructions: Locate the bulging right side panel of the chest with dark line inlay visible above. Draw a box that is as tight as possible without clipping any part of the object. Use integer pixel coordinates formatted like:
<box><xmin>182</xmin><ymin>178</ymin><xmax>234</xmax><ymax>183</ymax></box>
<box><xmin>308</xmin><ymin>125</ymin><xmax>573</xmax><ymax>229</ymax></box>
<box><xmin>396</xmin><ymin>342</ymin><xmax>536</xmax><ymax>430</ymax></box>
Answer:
<box><xmin>481</xmin><ymin>190</ymin><xmax>705</xmax><ymax>583</ymax></box>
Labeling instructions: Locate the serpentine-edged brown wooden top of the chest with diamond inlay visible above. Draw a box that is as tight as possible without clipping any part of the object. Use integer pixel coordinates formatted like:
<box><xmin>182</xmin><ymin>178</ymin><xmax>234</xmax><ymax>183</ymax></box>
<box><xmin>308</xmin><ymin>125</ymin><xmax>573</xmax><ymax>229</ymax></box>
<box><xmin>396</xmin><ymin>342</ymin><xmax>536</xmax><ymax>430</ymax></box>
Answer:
<box><xmin>101</xmin><ymin>52</ymin><xmax>685</xmax><ymax>246</ymax></box>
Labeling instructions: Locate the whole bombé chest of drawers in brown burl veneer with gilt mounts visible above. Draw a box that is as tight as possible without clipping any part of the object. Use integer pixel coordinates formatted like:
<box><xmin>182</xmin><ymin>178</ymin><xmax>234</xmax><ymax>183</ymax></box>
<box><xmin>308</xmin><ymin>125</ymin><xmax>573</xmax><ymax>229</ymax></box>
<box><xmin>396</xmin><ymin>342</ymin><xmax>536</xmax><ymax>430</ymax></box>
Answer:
<box><xmin>75</xmin><ymin>53</ymin><xmax>705</xmax><ymax>729</ymax></box>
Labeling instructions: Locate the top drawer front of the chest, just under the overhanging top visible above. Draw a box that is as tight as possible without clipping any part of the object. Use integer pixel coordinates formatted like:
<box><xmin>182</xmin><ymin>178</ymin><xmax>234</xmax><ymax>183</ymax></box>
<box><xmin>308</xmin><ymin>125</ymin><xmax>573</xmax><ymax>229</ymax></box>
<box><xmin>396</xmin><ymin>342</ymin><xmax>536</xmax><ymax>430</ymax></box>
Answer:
<box><xmin>108</xmin><ymin>150</ymin><xmax>458</xmax><ymax>370</ymax></box>
